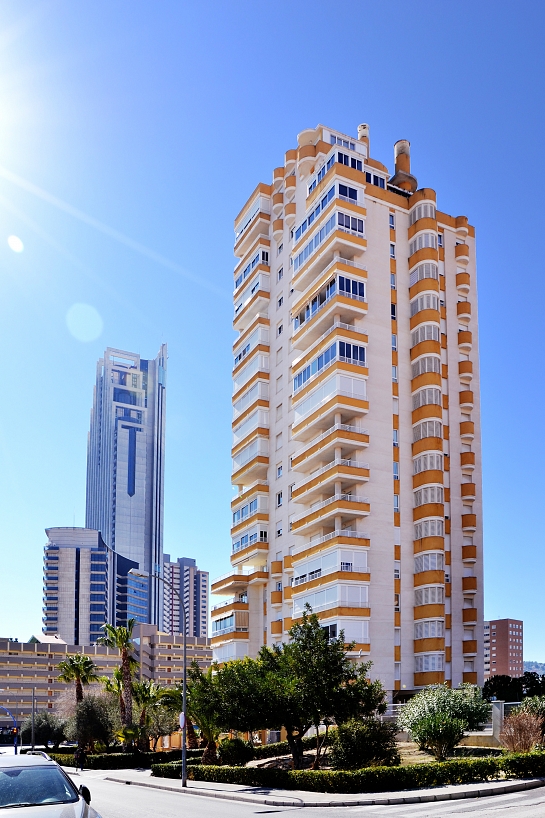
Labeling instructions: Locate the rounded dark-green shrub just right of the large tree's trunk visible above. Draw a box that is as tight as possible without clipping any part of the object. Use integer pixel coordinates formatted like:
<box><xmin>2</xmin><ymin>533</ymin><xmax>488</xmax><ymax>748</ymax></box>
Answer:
<box><xmin>331</xmin><ymin>718</ymin><xmax>400</xmax><ymax>770</ymax></box>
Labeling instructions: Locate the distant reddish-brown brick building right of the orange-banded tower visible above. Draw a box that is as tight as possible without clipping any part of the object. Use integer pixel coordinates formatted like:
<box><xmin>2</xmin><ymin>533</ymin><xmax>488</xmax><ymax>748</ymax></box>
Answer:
<box><xmin>484</xmin><ymin>619</ymin><xmax>524</xmax><ymax>679</ymax></box>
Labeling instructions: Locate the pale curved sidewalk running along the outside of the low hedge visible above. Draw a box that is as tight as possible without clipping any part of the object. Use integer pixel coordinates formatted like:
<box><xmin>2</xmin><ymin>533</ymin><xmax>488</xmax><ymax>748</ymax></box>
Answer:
<box><xmin>100</xmin><ymin>770</ymin><xmax>545</xmax><ymax>807</ymax></box>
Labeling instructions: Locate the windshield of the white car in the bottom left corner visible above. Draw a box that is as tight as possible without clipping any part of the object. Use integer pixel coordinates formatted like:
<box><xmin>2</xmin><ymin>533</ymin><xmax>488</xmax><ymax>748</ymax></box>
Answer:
<box><xmin>0</xmin><ymin>764</ymin><xmax>78</xmax><ymax>809</ymax></box>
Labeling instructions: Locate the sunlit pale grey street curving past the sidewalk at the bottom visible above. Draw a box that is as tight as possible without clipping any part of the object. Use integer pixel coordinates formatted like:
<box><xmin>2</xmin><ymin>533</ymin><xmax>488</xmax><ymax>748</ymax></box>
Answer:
<box><xmin>74</xmin><ymin>771</ymin><xmax>545</xmax><ymax>818</ymax></box>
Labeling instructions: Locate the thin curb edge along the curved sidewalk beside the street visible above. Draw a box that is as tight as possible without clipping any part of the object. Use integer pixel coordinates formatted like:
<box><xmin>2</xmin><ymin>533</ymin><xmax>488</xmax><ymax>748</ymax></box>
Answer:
<box><xmin>103</xmin><ymin>777</ymin><xmax>545</xmax><ymax>807</ymax></box>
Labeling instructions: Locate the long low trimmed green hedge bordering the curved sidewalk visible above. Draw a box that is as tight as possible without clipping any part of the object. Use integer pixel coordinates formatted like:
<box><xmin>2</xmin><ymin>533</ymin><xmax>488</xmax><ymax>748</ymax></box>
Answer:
<box><xmin>151</xmin><ymin>752</ymin><xmax>545</xmax><ymax>793</ymax></box>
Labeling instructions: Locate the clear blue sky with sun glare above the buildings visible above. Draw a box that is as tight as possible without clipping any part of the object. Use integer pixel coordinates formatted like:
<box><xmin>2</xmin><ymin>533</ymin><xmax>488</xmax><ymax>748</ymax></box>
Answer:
<box><xmin>0</xmin><ymin>0</ymin><xmax>545</xmax><ymax>661</ymax></box>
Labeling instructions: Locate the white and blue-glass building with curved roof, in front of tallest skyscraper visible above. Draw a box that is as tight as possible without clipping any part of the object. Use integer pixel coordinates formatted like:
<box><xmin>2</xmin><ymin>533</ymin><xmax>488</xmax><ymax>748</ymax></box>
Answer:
<box><xmin>43</xmin><ymin>528</ymin><xmax>149</xmax><ymax>645</ymax></box>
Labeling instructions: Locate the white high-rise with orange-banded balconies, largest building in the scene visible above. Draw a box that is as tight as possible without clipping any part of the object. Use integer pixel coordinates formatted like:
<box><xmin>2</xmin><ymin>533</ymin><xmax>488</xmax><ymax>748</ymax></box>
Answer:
<box><xmin>212</xmin><ymin>125</ymin><xmax>483</xmax><ymax>696</ymax></box>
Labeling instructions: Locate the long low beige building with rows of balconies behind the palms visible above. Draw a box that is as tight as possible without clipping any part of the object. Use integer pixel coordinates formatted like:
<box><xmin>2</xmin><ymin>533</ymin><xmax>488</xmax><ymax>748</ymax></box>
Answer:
<box><xmin>0</xmin><ymin>625</ymin><xmax>212</xmax><ymax>728</ymax></box>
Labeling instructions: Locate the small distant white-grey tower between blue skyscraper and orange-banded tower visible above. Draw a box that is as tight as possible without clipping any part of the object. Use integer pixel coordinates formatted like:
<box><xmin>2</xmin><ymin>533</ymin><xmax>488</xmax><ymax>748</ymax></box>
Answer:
<box><xmin>163</xmin><ymin>554</ymin><xmax>208</xmax><ymax>637</ymax></box>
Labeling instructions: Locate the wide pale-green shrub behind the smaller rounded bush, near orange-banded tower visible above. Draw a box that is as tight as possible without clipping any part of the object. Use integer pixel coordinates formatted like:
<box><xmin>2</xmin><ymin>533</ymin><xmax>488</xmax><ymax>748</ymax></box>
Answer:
<box><xmin>398</xmin><ymin>684</ymin><xmax>490</xmax><ymax>733</ymax></box>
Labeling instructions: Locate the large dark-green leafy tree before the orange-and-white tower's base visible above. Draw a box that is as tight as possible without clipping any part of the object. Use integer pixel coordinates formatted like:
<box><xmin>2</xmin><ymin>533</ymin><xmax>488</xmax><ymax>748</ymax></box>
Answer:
<box><xmin>258</xmin><ymin>606</ymin><xmax>386</xmax><ymax>769</ymax></box>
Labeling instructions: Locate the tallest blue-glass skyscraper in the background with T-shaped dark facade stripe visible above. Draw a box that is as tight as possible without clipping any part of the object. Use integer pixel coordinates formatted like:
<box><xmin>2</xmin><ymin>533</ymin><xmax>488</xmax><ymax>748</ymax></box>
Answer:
<box><xmin>85</xmin><ymin>344</ymin><xmax>167</xmax><ymax>627</ymax></box>
